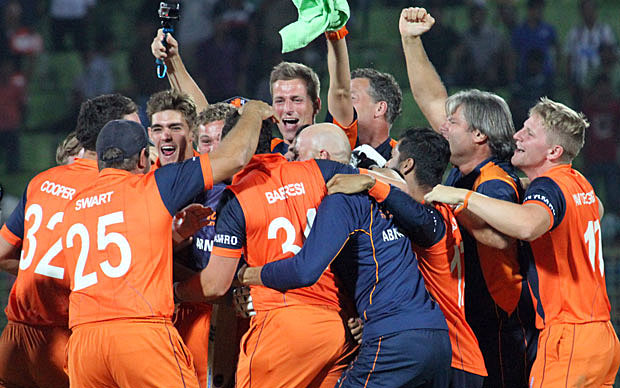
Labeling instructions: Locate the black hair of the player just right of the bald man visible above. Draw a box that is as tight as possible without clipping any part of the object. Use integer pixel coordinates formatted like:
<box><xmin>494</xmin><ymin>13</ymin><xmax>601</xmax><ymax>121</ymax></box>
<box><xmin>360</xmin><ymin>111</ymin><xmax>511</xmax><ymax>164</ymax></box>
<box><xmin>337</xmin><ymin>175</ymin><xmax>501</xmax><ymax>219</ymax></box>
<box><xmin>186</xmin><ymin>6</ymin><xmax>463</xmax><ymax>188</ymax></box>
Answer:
<box><xmin>398</xmin><ymin>128</ymin><xmax>450</xmax><ymax>187</ymax></box>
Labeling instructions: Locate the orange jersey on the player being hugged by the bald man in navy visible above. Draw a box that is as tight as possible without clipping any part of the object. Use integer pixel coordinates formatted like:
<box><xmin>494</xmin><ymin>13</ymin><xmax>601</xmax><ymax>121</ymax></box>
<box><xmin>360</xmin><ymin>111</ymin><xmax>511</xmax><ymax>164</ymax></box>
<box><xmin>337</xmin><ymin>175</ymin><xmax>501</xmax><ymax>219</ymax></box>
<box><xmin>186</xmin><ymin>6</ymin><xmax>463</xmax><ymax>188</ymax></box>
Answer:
<box><xmin>212</xmin><ymin>154</ymin><xmax>352</xmax><ymax>310</ymax></box>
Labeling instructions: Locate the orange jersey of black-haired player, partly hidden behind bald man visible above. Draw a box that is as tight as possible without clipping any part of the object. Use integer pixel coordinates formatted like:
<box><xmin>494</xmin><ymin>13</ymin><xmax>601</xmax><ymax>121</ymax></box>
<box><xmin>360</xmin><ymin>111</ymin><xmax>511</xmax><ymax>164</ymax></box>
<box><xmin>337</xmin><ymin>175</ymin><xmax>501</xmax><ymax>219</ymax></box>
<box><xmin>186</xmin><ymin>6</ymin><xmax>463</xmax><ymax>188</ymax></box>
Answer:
<box><xmin>413</xmin><ymin>204</ymin><xmax>487</xmax><ymax>376</ymax></box>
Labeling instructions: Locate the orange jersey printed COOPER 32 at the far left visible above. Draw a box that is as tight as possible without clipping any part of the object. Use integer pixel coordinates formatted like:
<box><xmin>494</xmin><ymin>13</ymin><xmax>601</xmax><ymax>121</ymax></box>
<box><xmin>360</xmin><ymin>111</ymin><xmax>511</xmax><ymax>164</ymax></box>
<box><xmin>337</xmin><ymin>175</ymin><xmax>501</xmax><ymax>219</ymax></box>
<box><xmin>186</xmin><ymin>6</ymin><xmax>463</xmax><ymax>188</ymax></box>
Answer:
<box><xmin>1</xmin><ymin>159</ymin><xmax>99</xmax><ymax>327</ymax></box>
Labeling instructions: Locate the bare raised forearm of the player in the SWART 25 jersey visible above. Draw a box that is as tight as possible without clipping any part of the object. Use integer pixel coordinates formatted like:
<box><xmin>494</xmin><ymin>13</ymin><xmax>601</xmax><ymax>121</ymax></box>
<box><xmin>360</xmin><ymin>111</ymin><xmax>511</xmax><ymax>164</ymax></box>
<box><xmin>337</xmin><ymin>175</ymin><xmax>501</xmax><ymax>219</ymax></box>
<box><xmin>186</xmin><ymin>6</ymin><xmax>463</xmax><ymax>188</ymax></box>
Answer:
<box><xmin>209</xmin><ymin>100</ymin><xmax>277</xmax><ymax>183</ymax></box>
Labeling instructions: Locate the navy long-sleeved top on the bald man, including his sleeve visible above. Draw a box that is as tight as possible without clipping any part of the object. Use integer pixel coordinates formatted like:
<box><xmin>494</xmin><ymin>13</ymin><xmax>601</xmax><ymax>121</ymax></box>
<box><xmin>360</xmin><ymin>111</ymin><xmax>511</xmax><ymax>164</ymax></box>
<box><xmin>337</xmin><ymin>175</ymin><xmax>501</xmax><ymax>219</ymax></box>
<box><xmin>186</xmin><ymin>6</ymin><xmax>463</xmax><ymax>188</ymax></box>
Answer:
<box><xmin>261</xmin><ymin>194</ymin><xmax>447</xmax><ymax>338</ymax></box>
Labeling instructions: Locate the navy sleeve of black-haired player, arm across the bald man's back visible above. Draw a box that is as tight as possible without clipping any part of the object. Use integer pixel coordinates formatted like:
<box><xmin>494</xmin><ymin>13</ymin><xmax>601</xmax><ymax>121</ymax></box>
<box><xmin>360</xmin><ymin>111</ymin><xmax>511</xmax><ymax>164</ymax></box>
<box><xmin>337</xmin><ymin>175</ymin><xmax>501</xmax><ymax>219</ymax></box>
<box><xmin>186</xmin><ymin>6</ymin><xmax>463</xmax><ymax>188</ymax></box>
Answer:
<box><xmin>381</xmin><ymin>186</ymin><xmax>446</xmax><ymax>248</ymax></box>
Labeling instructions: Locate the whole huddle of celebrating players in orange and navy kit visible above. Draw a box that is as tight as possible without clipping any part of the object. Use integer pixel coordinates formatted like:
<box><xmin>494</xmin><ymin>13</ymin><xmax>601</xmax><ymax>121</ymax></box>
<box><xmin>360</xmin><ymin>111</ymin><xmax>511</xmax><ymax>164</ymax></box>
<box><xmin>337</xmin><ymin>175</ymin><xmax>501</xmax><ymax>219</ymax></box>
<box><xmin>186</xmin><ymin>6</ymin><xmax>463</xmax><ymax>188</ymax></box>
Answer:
<box><xmin>0</xmin><ymin>8</ymin><xmax>620</xmax><ymax>388</ymax></box>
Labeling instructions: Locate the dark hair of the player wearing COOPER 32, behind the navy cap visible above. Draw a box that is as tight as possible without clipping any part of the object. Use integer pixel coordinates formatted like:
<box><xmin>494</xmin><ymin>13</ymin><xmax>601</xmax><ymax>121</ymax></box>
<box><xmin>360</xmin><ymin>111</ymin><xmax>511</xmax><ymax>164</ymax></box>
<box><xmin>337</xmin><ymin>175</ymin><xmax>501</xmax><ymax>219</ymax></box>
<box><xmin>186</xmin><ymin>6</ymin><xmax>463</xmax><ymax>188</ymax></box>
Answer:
<box><xmin>75</xmin><ymin>94</ymin><xmax>138</xmax><ymax>151</ymax></box>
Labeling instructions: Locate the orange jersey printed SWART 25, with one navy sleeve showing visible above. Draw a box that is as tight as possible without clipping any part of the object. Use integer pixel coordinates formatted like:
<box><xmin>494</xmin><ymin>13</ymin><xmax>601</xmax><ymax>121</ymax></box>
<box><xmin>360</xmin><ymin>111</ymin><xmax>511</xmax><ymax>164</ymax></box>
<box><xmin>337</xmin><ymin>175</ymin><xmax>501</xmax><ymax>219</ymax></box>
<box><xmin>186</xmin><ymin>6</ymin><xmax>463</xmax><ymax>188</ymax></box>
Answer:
<box><xmin>59</xmin><ymin>155</ymin><xmax>213</xmax><ymax>328</ymax></box>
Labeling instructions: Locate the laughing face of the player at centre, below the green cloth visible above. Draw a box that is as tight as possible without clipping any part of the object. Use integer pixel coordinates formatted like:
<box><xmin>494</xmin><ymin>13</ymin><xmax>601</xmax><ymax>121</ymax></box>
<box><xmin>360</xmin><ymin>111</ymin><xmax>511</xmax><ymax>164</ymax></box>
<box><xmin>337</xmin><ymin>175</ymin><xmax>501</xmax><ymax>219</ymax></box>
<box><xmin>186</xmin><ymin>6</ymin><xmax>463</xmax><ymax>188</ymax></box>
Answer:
<box><xmin>272</xmin><ymin>78</ymin><xmax>316</xmax><ymax>143</ymax></box>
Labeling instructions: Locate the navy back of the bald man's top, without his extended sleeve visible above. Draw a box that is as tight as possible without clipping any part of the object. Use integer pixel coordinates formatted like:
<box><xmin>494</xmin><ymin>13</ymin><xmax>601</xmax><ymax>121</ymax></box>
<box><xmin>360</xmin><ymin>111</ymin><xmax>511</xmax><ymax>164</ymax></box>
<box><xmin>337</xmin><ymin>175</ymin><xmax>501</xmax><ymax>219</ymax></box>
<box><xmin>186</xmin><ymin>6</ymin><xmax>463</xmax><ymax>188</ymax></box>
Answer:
<box><xmin>317</xmin><ymin>194</ymin><xmax>447</xmax><ymax>338</ymax></box>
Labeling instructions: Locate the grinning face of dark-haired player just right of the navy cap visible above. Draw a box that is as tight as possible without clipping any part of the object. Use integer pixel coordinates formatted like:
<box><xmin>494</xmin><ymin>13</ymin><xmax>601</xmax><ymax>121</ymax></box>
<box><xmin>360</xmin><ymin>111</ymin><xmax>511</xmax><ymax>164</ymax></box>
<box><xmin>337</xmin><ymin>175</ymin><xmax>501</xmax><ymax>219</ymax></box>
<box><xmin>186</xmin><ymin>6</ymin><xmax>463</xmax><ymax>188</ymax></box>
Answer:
<box><xmin>149</xmin><ymin>110</ymin><xmax>192</xmax><ymax>166</ymax></box>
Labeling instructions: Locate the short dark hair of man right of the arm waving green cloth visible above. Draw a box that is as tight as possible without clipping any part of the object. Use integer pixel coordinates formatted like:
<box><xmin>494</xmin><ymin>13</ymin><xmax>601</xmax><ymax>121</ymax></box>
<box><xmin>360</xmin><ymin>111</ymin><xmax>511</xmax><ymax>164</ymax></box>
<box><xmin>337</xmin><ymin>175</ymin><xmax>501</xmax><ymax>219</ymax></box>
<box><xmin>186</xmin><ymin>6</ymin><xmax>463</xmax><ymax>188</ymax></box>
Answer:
<box><xmin>351</xmin><ymin>68</ymin><xmax>403</xmax><ymax>124</ymax></box>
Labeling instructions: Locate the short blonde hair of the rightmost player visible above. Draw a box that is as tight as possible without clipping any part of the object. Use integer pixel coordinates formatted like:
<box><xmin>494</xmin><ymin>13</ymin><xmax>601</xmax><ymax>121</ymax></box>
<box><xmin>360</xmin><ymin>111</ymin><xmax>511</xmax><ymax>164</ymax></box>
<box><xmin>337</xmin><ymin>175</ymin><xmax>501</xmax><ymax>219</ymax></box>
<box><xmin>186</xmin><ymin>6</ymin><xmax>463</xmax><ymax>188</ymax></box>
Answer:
<box><xmin>530</xmin><ymin>97</ymin><xmax>590</xmax><ymax>162</ymax></box>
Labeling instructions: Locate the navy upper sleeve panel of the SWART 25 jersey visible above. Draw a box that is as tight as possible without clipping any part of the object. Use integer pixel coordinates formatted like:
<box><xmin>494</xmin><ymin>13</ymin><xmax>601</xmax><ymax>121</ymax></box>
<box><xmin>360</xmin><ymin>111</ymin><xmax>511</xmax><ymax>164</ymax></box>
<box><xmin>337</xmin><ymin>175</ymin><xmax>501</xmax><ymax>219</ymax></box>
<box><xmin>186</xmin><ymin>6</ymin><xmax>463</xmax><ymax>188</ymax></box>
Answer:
<box><xmin>155</xmin><ymin>157</ymin><xmax>211</xmax><ymax>216</ymax></box>
